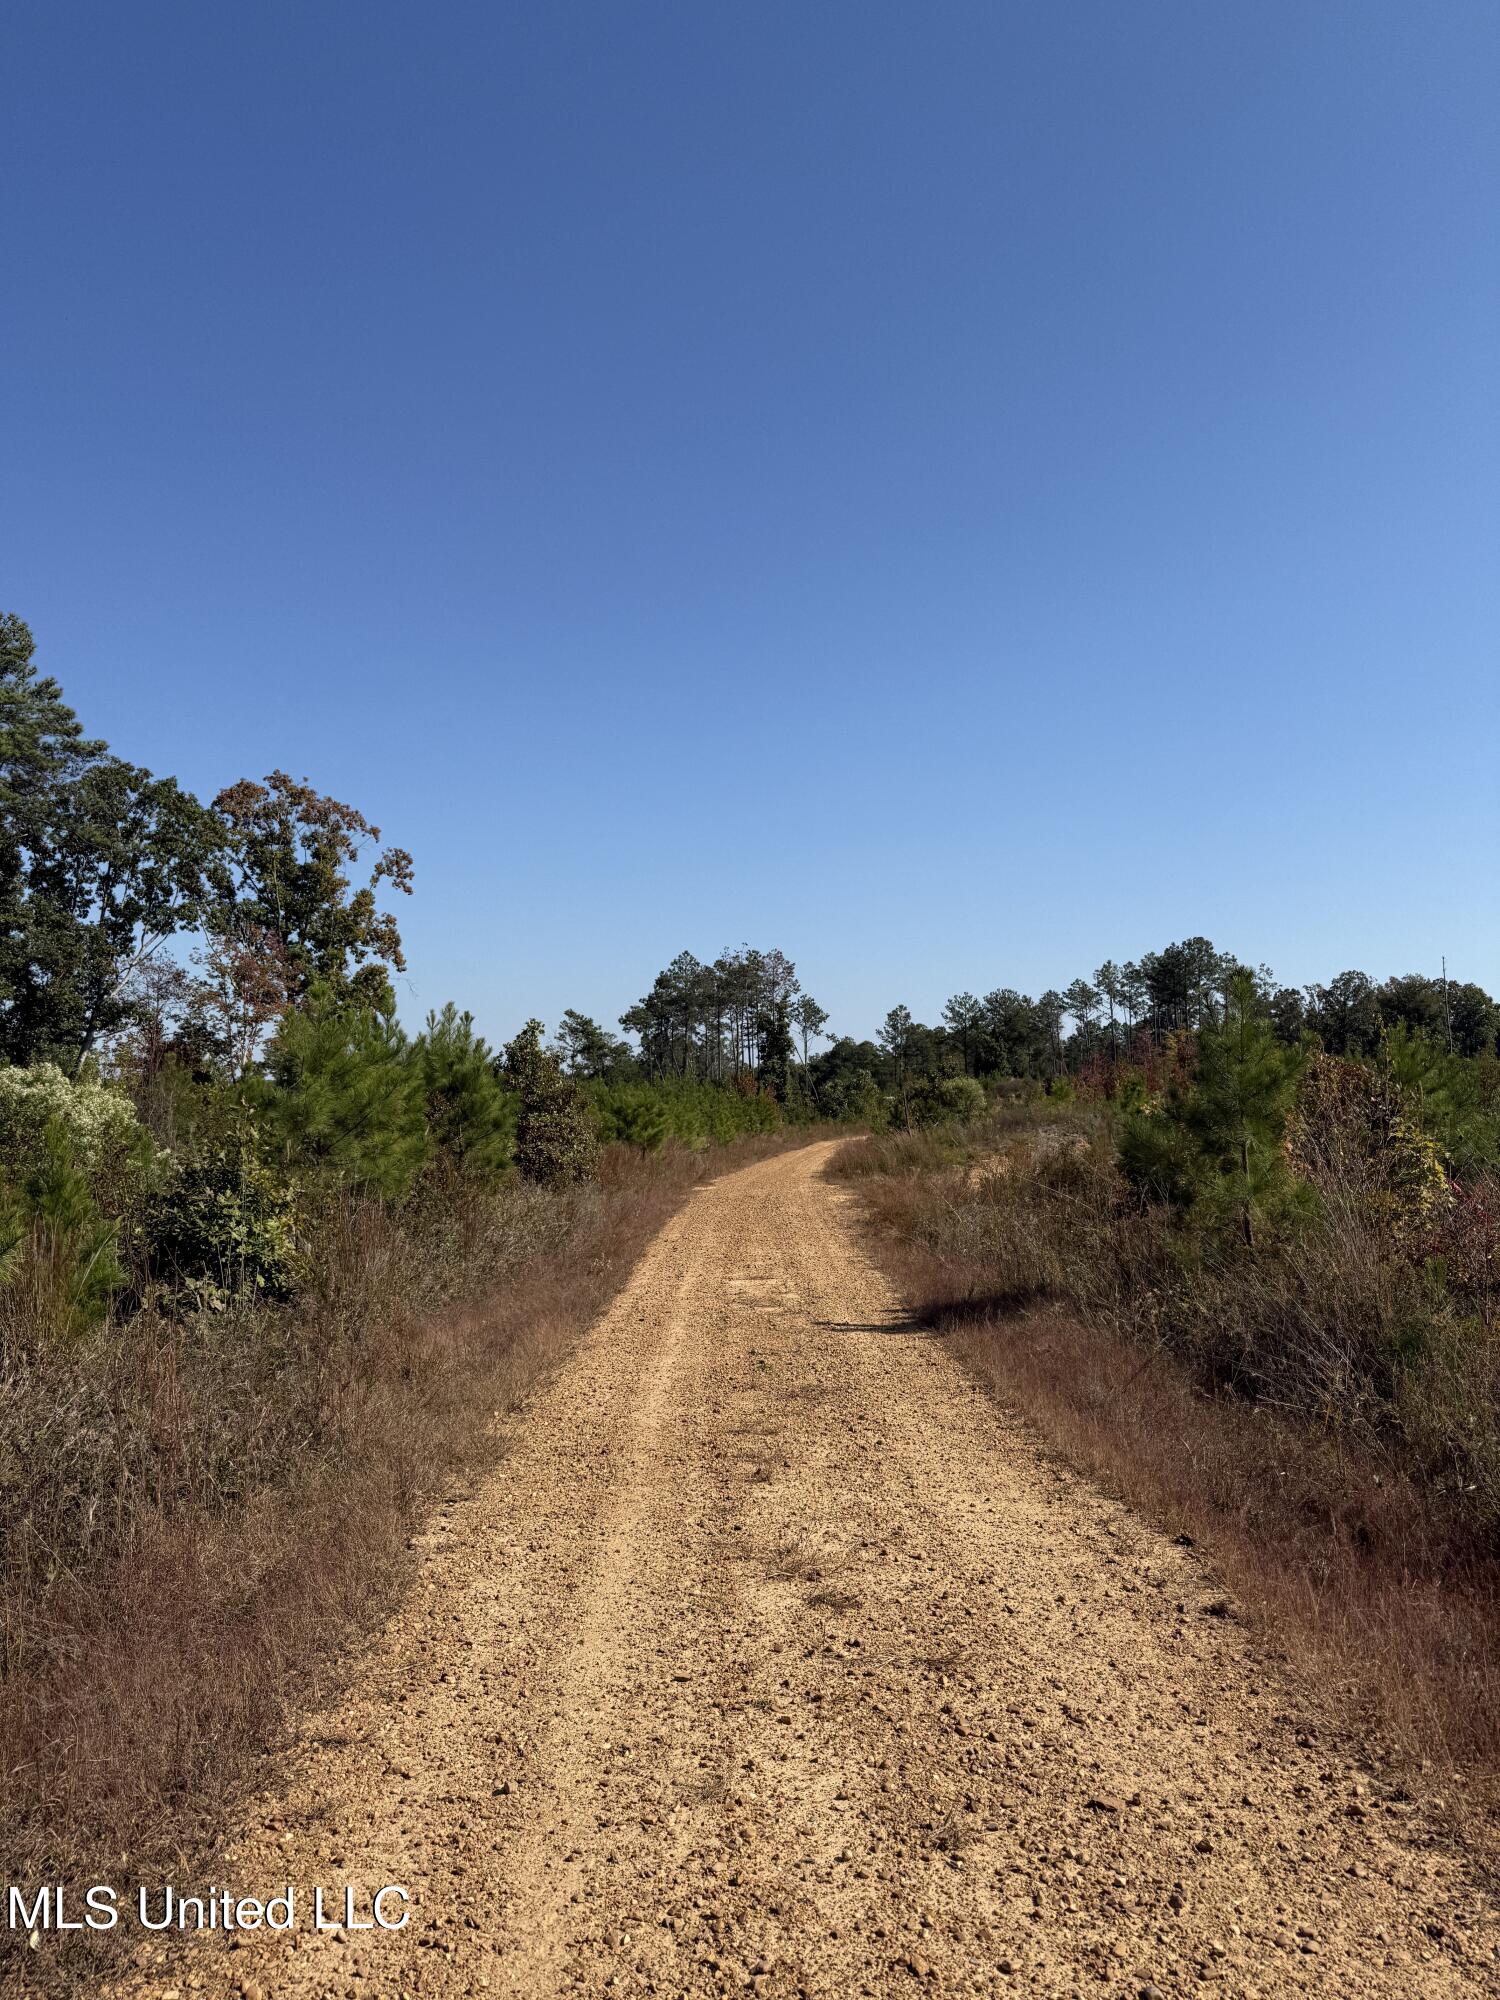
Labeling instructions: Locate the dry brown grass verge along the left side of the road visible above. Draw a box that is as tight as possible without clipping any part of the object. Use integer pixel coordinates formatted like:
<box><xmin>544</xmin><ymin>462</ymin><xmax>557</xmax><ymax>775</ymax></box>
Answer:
<box><xmin>0</xmin><ymin>1138</ymin><xmax>792</xmax><ymax>1976</ymax></box>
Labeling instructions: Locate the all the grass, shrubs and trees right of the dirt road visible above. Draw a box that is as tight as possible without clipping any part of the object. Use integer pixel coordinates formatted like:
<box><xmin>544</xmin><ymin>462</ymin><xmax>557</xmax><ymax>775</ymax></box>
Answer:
<box><xmin>838</xmin><ymin>960</ymin><xmax>1500</xmax><ymax>1792</ymax></box>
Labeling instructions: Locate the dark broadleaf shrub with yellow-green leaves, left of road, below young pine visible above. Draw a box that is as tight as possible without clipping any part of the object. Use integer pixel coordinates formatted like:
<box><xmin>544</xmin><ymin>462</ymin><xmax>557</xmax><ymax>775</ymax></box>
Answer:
<box><xmin>146</xmin><ymin>1124</ymin><xmax>302</xmax><ymax>1312</ymax></box>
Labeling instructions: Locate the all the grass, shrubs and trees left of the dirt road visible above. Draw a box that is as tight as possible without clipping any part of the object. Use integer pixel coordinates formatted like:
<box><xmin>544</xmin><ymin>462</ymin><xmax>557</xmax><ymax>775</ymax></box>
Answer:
<box><xmin>0</xmin><ymin>616</ymin><xmax>836</xmax><ymax>1944</ymax></box>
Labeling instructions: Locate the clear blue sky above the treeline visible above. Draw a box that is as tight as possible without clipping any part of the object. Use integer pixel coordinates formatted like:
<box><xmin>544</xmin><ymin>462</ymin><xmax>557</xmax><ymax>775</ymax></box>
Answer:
<box><xmin>0</xmin><ymin>0</ymin><xmax>1500</xmax><ymax>1034</ymax></box>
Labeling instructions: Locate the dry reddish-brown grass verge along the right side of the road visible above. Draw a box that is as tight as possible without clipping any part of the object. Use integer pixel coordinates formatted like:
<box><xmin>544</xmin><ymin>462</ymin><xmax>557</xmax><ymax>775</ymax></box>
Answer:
<box><xmin>844</xmin><ymin>1120</ymin><xmax>1500</xmax><ymax>1810</ymax></box>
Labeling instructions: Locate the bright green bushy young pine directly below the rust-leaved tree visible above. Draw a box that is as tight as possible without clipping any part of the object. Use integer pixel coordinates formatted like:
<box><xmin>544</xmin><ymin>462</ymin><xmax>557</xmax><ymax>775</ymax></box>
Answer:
<box><xmin>250</xmin><ymin>986</ymin><xmax>432</xmax><ymax>1200</ymax></box>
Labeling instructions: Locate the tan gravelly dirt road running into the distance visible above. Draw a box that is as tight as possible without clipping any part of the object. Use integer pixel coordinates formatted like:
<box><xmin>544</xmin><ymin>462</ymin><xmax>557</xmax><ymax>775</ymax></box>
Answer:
<box><xmin>144</xmin><ymin>1146</ymin><xmax>1500</xmax><ymax>2000</ymax></box>
